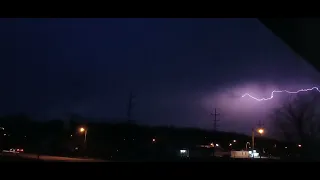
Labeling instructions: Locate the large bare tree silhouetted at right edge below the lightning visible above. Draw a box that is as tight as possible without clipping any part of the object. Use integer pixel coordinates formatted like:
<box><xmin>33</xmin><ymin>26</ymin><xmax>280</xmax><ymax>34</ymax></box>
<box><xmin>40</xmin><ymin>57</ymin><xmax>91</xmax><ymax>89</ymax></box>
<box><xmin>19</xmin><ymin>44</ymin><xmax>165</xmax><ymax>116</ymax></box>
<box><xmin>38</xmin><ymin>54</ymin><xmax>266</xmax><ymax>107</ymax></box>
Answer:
<box><xmin>272</xmin><ymin>94</ymin><xmax>320</xmax><ymax>160</ymax></box>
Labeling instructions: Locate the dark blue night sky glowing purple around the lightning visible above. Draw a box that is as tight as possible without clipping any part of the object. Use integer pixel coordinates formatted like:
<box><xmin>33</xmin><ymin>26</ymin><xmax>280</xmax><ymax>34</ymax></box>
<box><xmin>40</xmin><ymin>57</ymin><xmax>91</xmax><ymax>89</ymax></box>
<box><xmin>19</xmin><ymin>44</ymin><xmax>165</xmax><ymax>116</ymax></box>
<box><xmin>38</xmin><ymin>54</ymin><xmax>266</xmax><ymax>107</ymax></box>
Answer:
<box><xmin>0</xmin><ymin>18</ymin><xmax>319</xmax><ymax>133</ymax></box>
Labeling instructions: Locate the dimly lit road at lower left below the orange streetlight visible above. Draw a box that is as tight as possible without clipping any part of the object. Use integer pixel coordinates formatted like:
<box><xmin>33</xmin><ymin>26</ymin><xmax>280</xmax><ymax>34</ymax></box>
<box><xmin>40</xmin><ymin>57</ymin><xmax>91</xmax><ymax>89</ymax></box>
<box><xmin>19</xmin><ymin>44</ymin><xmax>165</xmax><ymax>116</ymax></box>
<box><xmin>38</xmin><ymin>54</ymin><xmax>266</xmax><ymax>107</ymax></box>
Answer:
<box><xmin>2</xmin><ymin>152</ymin><xmax>107</xmax><ymax>162</ymax></box>
